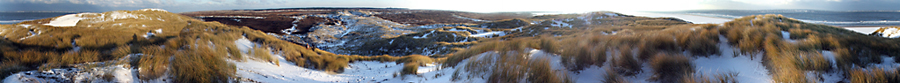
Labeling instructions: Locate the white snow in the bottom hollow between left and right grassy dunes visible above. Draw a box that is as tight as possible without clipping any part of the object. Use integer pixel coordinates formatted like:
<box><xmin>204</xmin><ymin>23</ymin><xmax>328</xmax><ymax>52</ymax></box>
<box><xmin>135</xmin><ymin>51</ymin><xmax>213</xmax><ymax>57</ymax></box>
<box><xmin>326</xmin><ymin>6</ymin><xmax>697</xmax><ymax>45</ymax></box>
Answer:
<box><xmin>231</xmin><ymin>52</ymin><xmax>455</xmax><ymax>83</ymax></box>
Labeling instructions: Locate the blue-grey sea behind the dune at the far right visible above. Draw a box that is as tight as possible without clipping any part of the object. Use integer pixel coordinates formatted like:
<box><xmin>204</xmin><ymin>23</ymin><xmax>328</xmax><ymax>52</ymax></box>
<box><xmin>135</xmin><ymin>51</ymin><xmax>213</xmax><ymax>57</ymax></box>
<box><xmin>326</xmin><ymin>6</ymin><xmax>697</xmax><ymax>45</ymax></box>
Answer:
<box><xmin>666</xmin><ymin>10</ymin><xmax>900</xmax><ymax>26</ymax></box>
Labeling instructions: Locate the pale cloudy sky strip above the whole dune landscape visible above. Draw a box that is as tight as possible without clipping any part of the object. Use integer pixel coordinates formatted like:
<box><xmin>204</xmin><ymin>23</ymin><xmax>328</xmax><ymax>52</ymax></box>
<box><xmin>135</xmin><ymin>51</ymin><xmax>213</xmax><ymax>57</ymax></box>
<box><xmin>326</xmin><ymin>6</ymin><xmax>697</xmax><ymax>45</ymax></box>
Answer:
<box><xmin>0</xmin><ymin>0</ymin><xmax>900</xmax><ymax>12</ymax></box>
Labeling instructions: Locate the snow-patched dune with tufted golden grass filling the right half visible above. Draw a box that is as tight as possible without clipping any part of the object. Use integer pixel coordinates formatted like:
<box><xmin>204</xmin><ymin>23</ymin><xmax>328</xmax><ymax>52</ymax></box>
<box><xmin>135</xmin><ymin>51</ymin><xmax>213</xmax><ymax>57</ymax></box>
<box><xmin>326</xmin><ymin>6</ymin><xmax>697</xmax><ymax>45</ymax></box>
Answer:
<box><xmin>444</xmin><ymin>15</ymin><xmax>900</xmax><ymax>83</ymax></box>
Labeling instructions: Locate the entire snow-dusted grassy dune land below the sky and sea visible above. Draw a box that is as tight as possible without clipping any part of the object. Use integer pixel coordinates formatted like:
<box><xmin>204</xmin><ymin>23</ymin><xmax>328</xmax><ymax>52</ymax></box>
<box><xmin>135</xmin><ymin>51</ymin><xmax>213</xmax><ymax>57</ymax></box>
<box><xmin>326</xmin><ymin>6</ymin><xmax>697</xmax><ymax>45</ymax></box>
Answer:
<box><xmin>0</xmin><ymin>8</ymin><xmax>900</xmax><ymax>83</ymax></box>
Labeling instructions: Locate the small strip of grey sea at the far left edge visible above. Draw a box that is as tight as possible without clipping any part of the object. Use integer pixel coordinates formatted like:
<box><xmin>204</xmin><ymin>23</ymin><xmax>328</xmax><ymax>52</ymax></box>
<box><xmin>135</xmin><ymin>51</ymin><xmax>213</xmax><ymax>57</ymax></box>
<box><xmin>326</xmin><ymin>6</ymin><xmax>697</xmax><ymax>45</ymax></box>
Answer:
<box><xmin>0</xmin><ymin>12</ymin><xmax>74</xmax><ymax>24</ymax></box>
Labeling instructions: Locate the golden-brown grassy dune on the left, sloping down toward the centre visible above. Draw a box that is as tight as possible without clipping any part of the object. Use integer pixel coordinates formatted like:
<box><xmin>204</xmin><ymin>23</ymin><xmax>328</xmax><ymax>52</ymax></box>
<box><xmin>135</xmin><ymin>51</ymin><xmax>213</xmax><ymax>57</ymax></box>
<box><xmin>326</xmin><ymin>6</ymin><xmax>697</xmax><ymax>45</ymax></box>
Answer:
<box><xmin>0</xmin><ymin>9</ymin><xmax>430</xmax><ymax>83</ymax></box>
